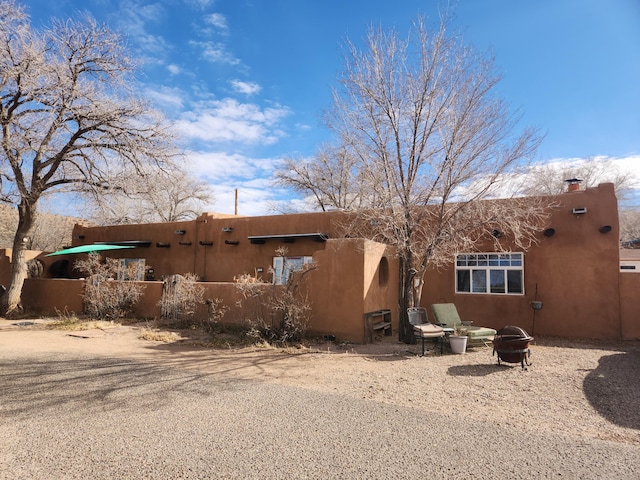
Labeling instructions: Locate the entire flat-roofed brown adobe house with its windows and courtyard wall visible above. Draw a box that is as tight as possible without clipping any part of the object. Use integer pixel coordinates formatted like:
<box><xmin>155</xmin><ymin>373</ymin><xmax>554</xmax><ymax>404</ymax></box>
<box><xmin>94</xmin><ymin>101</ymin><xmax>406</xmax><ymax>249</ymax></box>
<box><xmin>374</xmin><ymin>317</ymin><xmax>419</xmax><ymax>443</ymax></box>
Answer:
<box><xmin>5</xmin><ymin>184</ymin><xmax>640</xmax><ymax>343</ymax></box>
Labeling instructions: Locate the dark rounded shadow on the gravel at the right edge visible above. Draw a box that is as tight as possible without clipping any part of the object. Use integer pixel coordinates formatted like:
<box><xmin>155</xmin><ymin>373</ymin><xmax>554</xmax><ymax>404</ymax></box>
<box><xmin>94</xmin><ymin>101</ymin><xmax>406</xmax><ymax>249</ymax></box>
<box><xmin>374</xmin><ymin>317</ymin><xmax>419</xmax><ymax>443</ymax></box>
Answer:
<box><xmin>583</xmin><ymin>349</ymin><xmax>640</xmax><ymax>430</ymax></box>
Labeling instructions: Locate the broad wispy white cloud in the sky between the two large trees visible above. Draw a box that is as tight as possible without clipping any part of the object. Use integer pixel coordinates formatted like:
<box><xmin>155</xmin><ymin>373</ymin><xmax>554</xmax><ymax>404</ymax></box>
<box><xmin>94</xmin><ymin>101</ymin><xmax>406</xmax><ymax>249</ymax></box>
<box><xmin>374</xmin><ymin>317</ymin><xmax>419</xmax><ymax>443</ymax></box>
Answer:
<box><xmin>177</xmin><ymin>98</ymin><xmax>290</xmax><ymax>145</ymax></box>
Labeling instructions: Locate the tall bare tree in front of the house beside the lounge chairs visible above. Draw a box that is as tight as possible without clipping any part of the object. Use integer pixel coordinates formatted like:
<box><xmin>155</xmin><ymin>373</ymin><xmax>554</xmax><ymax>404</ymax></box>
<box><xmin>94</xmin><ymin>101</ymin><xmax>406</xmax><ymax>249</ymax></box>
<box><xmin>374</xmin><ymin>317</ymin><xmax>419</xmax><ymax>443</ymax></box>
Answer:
<box><xmin>320</xmin><ymin>18</ymin><xmax>548</xmax><ymax>342</ymax></box>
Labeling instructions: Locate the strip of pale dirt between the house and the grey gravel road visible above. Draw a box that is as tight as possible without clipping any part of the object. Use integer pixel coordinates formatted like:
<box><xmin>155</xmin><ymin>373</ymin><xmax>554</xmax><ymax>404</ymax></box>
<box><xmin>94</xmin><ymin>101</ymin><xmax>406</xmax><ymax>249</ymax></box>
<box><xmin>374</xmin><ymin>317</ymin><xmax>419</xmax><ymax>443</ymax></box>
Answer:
<box><xmin>0</xmin><ymin>319</ymin><xmax>640</xmax><ymax>444</ymax></box>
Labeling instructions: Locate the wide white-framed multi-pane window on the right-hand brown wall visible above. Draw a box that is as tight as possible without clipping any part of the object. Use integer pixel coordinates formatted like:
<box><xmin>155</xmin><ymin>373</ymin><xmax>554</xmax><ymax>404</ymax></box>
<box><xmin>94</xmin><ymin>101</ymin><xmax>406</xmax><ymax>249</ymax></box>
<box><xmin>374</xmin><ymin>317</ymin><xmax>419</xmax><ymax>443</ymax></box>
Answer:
<box><xmin>456</xmin><ymin>253</ymin><xmax>524</xmax><ymax>295</ymax></box>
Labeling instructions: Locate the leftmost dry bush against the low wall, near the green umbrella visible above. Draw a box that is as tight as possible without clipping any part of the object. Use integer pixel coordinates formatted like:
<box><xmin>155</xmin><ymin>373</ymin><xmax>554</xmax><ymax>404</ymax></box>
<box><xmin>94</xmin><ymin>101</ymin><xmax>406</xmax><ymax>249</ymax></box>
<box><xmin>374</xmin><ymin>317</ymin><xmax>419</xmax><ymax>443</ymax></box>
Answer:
<box><xmin>73</xmin><ymin>255</ymin><xmax>144</xmax><ymax>320</ymax></box>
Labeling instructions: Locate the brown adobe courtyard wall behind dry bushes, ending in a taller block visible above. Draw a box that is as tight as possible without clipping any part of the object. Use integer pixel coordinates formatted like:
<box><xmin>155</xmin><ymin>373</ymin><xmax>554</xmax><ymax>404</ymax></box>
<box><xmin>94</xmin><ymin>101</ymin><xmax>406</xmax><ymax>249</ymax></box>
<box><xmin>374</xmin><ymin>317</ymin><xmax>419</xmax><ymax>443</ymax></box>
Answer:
<box><xmin>18</xmin><ymin>239</ymin><xmax>398</xmax><ymax>343</ymax></box>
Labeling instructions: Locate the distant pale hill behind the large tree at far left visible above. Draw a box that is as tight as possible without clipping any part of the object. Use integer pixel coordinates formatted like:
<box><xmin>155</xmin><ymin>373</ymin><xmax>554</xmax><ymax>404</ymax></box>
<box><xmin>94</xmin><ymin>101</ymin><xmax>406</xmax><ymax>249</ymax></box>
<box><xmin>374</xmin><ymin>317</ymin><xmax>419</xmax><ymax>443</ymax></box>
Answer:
<box><xmin>0</xmin><ymin>204</ymin><xmax>82</xmax><ymax>252</ymax></box>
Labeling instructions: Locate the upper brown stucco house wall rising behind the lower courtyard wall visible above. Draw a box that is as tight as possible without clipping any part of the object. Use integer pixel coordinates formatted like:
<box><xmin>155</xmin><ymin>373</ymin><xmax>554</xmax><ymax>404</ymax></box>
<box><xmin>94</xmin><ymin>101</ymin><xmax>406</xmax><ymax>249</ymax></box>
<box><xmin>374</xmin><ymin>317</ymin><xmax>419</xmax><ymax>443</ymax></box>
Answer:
<box><xmin>64</xmin><ymin>212</ymin><xmax>343</xmax><ymax>282</ymax></box>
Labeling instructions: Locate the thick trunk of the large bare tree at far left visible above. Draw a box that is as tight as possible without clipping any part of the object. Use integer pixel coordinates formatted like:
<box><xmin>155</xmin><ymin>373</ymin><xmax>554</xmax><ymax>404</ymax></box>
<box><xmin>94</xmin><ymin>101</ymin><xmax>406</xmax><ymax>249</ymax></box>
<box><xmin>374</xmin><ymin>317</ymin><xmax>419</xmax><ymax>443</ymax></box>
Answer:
<box><xmin>0</xmin><ymin>199</ymin><xmax>35</xmax><ymax>316</ymax></box>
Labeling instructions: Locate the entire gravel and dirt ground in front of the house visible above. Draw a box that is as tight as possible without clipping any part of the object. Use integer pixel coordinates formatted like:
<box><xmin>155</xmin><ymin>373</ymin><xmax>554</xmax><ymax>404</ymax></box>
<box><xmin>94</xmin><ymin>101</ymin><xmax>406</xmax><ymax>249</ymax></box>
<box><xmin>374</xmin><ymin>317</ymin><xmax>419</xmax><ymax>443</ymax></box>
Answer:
<box><xmin>0</xmin><ymin>324</ymin><xmax>640</xmax><ymax>479</ymax></box>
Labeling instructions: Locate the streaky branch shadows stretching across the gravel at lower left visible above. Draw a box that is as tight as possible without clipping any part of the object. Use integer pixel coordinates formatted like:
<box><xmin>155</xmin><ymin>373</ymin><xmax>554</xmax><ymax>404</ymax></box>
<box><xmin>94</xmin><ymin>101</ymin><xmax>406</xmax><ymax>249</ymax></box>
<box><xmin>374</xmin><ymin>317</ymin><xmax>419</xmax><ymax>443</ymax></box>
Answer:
<box><xmin>0</xmin><ymin>356</ymin><xmax>277</xmax><ymax>419</ymax></box>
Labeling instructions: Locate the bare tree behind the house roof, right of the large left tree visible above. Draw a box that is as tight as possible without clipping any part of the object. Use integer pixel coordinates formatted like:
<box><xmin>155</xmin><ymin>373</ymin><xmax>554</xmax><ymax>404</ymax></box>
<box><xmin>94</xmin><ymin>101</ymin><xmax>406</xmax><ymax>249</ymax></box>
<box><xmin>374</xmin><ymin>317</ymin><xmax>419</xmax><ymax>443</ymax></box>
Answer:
<box><xmin>88</xmin><ymin>167</ymin><xmax>214</xmax><ymax>225</ymax></box>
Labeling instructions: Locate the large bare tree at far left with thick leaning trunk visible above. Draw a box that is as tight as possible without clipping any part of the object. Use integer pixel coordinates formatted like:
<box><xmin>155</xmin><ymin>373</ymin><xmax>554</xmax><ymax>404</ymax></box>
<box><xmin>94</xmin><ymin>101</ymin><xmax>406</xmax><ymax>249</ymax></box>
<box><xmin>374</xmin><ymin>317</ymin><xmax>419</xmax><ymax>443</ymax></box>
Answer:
<box><xmin>0</xmin><ymin>0</ymin><xmax>173</xmax><ymax>314</ymax></box>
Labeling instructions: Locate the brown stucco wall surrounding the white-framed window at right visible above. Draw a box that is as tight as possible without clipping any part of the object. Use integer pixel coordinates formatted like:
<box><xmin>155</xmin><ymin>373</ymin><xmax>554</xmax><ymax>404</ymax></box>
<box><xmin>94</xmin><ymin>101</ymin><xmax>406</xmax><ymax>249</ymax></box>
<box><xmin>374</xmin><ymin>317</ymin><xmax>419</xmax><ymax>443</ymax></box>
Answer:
<box><xmin>423</xmin><ymin>184</ymin><xmax>621</xmax><ymax>338</ymax></box>
